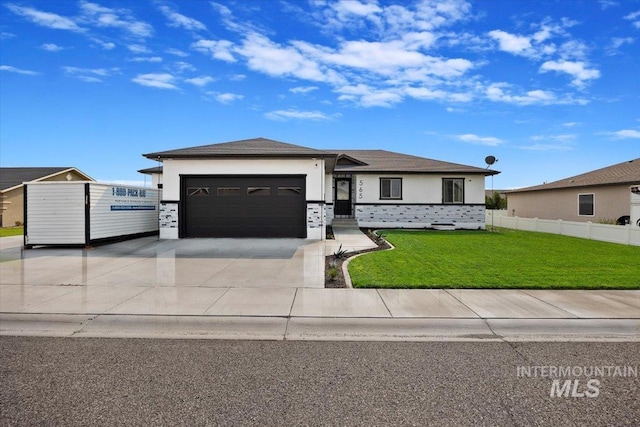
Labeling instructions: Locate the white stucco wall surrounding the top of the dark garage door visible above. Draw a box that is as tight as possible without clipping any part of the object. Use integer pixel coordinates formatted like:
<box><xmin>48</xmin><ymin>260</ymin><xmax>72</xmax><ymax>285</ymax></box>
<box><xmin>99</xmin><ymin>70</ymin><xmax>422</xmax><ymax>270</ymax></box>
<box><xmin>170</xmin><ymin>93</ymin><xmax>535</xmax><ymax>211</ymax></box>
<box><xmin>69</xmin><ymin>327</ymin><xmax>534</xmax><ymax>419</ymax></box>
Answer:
<box><xmin>163</xmin><ymin>158</ymin><xmax>325</xmax><ymax>201</ymax></box>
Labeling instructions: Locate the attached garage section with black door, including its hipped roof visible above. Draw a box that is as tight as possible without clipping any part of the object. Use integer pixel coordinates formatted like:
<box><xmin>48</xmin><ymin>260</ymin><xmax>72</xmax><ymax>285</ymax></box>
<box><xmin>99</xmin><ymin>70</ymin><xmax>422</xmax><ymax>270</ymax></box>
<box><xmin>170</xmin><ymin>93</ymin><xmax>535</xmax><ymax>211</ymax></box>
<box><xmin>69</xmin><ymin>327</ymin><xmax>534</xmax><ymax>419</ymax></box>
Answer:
<box><xmin>145</xmin><ymin>138</ymin><xmax>336</xmax><ymax>239</ymax></box>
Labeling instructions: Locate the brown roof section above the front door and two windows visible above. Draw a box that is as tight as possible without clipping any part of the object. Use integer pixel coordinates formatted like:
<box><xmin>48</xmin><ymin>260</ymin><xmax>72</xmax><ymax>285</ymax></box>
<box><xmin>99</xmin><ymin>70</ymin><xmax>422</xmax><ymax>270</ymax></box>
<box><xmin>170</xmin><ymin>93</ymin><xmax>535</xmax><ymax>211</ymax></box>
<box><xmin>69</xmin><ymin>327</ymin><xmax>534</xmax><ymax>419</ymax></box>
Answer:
<box><xmin>327</xmin><ymin>150</ymin><xmax>500</xmax><ymax>175</ymax></box>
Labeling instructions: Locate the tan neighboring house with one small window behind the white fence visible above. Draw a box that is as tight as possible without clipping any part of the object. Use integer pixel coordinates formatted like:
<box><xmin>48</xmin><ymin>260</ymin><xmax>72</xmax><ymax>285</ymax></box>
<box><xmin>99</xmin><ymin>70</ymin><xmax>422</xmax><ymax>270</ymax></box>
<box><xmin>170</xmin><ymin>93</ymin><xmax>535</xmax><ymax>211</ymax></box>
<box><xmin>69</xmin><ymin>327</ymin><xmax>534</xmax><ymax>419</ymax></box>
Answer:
<box><xmin>507</xmin><ymin>158</ymin><xmax>640</xmax><ymax>222</ymax></box>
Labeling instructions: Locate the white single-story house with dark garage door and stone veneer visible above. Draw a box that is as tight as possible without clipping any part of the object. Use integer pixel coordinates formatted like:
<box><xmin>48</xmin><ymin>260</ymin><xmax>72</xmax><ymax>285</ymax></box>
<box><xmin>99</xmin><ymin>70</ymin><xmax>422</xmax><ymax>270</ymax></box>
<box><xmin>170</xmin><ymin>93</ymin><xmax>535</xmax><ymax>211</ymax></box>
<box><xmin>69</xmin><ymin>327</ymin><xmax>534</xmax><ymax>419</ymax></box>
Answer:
<box><xmin>141</xmin><ymin>138</ymin><xmax>498</xmax><ymax>239</ymax></box>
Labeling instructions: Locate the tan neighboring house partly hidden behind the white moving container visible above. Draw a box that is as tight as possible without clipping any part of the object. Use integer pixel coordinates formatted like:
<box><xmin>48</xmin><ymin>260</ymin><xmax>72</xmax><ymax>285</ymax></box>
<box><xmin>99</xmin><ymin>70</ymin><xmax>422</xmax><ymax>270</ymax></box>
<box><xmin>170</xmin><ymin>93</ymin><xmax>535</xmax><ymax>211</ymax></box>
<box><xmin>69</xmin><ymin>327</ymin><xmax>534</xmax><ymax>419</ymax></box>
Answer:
<box><xmin>0</xmin><ymin>167</ymin><xmax>93</xmax><ymax>227</ymax></box>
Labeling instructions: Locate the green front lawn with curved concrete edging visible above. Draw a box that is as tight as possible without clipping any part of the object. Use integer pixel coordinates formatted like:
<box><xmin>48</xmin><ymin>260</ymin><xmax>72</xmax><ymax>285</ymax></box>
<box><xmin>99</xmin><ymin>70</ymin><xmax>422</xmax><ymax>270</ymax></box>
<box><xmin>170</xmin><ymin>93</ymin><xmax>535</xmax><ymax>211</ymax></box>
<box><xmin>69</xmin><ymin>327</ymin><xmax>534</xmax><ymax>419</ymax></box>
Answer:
<box><xmin>349</xmin><ymin>229</ymin><xmax>640</xmax><ymax>289</ymax></box>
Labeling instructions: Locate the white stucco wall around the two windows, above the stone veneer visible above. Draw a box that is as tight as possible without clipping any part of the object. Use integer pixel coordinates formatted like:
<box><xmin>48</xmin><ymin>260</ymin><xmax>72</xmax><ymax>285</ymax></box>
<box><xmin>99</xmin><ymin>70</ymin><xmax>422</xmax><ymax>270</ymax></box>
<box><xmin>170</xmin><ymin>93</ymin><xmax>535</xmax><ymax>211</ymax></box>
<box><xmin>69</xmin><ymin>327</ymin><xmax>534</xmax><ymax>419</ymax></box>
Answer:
<box><xmin>354</xmin><ymin>174</ymin><xmax>484</xmax><ymax>204</ymax></box>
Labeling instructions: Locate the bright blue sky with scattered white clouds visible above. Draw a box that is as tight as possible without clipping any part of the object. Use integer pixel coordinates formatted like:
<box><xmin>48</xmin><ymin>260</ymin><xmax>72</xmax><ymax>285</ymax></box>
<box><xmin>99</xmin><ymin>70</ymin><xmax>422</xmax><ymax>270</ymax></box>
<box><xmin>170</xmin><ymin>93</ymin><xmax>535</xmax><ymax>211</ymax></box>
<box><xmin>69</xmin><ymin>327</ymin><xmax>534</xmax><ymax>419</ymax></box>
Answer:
<box><xmin>0</xmin><ymin>0</ymin><xmax>640</xmax><ymax>188</ymax></box>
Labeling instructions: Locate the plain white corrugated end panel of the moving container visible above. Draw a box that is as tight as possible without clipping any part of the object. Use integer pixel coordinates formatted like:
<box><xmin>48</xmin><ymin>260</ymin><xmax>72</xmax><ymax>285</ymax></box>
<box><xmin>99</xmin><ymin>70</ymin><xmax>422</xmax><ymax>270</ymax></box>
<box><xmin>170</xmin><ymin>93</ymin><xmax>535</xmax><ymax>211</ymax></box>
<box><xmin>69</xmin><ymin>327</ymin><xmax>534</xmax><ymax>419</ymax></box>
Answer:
<box><xmin>25</xmin><ymin>182</ymin><xmax>85</xmax><ymax>245</ymax></box>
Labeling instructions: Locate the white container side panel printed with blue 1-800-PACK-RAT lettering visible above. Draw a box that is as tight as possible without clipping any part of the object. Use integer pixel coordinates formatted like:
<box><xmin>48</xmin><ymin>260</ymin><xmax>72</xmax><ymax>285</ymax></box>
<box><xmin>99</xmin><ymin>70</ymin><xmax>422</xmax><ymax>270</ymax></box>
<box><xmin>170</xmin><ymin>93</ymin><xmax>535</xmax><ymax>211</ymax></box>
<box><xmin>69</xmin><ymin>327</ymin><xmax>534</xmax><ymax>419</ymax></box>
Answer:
<box><xmin>89</xmin><ymin>183</ymin><xmax>158</xmax><ymax>240</ymax></box>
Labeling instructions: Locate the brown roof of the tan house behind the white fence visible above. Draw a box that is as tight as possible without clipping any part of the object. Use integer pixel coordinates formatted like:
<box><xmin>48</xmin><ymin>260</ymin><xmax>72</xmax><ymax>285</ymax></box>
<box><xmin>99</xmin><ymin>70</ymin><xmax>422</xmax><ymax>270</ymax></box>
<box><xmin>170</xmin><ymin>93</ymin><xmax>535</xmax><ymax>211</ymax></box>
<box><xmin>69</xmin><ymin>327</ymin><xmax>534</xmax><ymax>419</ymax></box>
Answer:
<box><xmin>509</xmin><ymin>158</ymin><xmax>640</xmax><ymax>193</ymax></box>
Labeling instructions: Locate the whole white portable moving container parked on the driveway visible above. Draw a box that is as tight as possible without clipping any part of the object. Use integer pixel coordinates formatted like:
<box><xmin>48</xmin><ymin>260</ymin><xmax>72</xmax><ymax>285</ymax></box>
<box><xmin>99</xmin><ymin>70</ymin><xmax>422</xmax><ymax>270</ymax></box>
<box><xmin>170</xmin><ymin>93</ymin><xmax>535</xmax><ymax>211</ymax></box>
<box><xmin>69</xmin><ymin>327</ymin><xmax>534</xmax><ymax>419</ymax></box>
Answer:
<box><xmin>24</xmin><ymin>181</ymin><xmax>159</xmax><ymax>248</ymax></box>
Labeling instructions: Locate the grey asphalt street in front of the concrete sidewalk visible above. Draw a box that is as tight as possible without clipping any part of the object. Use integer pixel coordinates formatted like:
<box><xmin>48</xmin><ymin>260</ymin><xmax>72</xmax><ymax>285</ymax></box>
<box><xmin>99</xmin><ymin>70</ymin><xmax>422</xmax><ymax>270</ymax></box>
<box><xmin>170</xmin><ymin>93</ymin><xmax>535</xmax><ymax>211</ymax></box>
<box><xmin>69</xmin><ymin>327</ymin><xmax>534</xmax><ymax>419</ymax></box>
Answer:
<box><xmin>0</xmin><ymin>336</ymin><xmax>640</xmax><ymax>426</ymax></box>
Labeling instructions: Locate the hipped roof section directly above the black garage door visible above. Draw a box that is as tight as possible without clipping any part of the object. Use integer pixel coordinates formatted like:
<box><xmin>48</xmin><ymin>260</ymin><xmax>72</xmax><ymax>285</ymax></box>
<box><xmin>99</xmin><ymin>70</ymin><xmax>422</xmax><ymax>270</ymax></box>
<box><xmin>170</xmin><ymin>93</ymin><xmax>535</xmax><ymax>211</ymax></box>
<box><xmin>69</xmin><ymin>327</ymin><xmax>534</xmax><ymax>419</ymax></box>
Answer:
<box><xmin>144</xmin><ymin>138</ymin><xmax>335</xmax><ymax>160</ymax></box>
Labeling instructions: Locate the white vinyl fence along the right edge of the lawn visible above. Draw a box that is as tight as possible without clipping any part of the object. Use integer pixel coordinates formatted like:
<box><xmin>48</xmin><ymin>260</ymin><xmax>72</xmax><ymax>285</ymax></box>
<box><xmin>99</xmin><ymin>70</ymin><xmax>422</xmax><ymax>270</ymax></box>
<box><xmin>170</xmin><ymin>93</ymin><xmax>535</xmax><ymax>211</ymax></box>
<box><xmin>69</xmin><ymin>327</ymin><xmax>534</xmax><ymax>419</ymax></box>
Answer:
<box><xmin>485</xmin><ymin>209</ymin><xmax>640</xmax><ymax>246</ymax></box>
